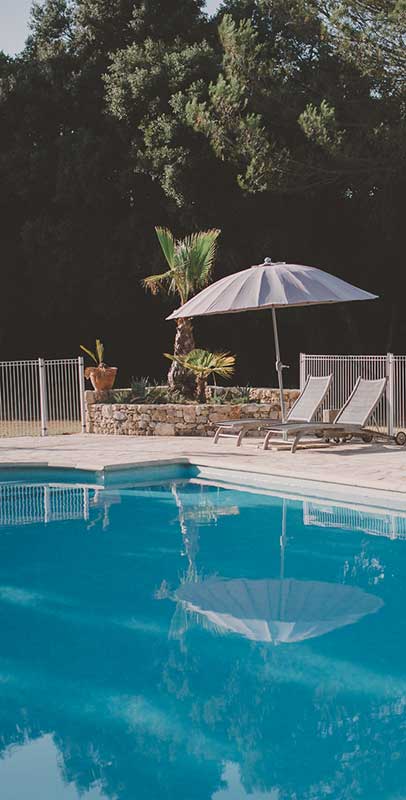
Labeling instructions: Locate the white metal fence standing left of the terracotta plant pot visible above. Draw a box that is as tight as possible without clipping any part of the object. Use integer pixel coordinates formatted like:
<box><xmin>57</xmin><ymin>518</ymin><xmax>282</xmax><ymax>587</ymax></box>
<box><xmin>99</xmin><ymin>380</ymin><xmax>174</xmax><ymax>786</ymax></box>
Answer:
<box><xmin>0</xmin><ymin>357</ymin><xmax>86</xmax><ymax>436</ymax></box>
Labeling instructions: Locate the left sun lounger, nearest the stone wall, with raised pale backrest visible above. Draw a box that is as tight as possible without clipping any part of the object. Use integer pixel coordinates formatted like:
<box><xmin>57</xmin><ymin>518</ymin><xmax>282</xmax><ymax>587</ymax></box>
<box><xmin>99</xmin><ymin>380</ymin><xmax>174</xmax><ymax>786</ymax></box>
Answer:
<box><xmin>213</xmin><ymin>375</ymin><xmax>333</xmax><ymax>447</ymax></box>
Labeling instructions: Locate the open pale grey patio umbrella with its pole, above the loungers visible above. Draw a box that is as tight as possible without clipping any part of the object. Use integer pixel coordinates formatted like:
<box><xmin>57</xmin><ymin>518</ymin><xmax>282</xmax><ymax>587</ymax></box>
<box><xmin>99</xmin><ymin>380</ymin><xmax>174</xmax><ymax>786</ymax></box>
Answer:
<box><xmin>168</xmin><ymin>258</ymin><xmax>377</xmax><ymax>420</ymax></box>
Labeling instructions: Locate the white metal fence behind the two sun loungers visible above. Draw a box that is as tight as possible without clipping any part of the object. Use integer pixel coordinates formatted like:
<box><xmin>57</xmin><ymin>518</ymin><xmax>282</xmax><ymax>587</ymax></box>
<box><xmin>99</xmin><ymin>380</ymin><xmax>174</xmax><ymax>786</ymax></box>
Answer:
<box><xmin>300</xmin><ymin>353</ymin><xmax>406</xmax><ymax>434</ymax></box>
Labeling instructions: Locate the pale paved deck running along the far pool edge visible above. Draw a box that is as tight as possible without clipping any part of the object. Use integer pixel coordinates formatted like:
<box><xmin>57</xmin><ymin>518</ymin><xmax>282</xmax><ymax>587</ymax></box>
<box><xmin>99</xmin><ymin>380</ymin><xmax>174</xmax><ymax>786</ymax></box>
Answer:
<box><xmin>0</xmin><ymin>434</ymin><xmax>406</xmax><ymax>506</ymax></box>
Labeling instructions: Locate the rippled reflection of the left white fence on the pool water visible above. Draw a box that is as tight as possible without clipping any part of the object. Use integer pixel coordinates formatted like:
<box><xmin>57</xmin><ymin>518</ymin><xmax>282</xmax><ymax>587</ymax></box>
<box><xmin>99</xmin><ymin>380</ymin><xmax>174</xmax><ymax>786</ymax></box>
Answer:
<box><xmin>0</xmin><ymin>483</ymin><xmax>90</xmax><ymax>527</ymax></box>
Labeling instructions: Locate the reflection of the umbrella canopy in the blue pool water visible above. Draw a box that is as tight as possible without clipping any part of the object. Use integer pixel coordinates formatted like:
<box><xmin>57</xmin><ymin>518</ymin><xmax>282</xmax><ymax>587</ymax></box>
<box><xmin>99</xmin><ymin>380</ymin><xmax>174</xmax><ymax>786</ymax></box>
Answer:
<box><xmin>176</xmin><ymin>578</ymin><xmax>383</xmax><ymax>644</ymax></box>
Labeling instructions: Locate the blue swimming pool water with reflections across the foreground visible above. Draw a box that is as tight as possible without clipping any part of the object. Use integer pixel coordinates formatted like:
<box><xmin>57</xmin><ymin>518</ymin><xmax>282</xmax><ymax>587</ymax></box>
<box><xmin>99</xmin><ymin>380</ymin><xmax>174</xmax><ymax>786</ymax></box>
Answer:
<box><xmin>0</xmin><ymin>468</ymin><xmax>406</xmax><ymax>800</ymax></box>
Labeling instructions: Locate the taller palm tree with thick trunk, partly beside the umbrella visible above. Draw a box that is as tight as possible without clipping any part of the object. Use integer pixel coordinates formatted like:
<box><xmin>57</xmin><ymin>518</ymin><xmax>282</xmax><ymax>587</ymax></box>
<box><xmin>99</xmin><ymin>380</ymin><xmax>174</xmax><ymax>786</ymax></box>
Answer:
<box><xmin>143</xmin><ymin>228</ymin><xmax>220</xmax><ymax>394</ymax></box>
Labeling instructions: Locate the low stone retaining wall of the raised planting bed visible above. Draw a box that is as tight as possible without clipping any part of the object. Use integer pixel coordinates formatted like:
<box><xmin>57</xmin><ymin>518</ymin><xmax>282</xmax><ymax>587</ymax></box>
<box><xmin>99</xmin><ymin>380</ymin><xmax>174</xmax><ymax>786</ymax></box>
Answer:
<box><xmin>86</xmin><ymin>389</ymin><xmax>298</xmax><ymax>436</ymax></box>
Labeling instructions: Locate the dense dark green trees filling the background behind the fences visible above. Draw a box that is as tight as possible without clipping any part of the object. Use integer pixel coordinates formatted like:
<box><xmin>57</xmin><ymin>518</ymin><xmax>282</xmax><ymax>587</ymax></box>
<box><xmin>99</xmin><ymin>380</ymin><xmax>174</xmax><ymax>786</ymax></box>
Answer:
<box><xmin>0</xmin><ymin>0</ymin><xmax>406</xmax><ymax>383</ymax></box>
